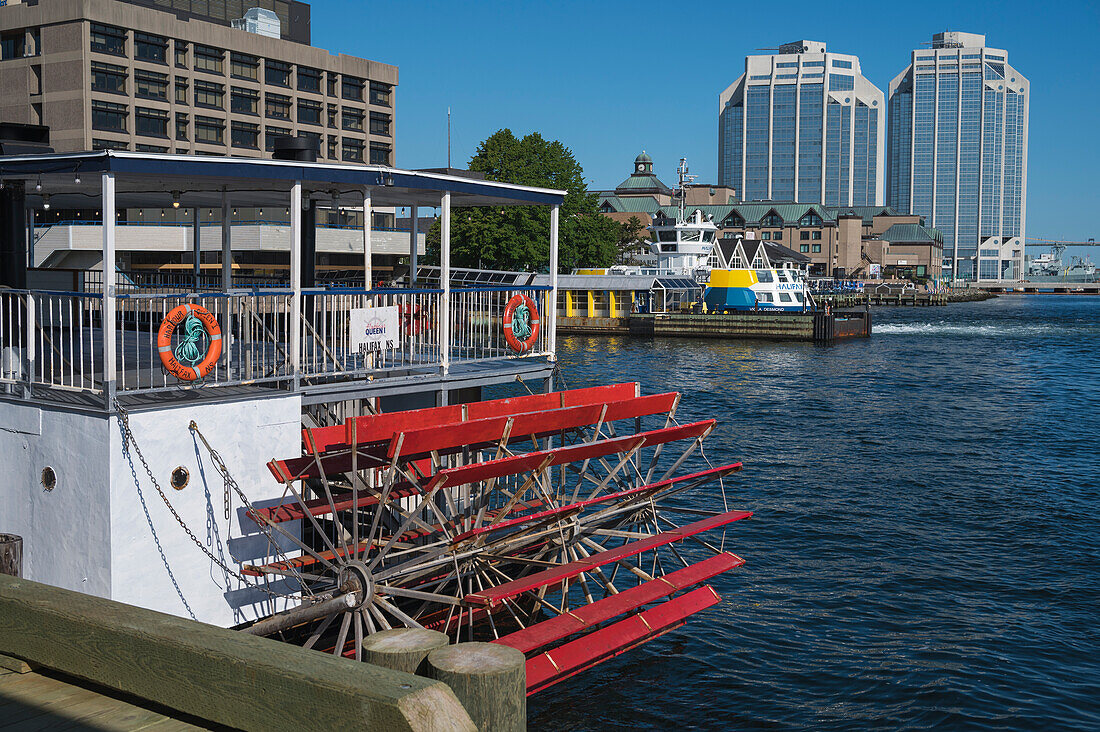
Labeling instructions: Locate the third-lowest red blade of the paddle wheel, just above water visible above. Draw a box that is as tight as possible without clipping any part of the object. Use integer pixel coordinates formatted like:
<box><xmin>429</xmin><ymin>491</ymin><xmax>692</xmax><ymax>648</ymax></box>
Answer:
<box><xmin>465</xmin><ymin>511</ymin><xmax>752</xmax><ymax>608</ymax></box>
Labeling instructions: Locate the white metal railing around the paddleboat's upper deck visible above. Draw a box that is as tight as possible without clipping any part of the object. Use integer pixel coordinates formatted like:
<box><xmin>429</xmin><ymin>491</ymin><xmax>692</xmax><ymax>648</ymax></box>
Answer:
<box><xmin>0</xmin><ymin>286</ymin><xmax>552</xmax><ymax>400</ymax></box>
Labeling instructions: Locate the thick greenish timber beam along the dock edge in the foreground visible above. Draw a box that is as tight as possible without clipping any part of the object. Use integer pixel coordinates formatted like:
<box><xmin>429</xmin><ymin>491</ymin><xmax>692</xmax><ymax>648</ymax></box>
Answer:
<box><xmin>0</xmin><ymin>576</ymin><xmax>473</xmax><ymax>730</ymax></box>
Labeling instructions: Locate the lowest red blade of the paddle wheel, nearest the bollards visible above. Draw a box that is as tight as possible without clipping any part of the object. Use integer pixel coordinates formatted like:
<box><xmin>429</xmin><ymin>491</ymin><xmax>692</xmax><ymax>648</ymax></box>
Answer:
<box><xmin>527</xmin><ymin>586</ymin><xmax>721</xmax><ymax>696</ymax></box>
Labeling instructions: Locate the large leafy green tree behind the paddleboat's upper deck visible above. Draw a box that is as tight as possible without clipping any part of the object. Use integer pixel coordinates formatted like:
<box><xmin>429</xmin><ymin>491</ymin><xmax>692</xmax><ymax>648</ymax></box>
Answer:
<box><xmin>427</xmin><ymin>129</ymin><xmax>620</xmax><ymax>272</ymax></box>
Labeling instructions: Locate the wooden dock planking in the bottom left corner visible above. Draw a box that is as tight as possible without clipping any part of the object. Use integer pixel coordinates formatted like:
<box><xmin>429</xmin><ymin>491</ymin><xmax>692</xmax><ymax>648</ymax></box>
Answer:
<box><xmin>0</xmin><ymin>668</ymin><xmax>216</xmax><ymax>732</ymax></box>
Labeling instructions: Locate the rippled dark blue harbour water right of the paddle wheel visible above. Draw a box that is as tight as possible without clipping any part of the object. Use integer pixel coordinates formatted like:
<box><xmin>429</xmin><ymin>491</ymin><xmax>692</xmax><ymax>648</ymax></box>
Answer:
<box><xmin>529</xmin><ymin>296</ymin><xmax>1100</xmax><ymax>730</ymax></box>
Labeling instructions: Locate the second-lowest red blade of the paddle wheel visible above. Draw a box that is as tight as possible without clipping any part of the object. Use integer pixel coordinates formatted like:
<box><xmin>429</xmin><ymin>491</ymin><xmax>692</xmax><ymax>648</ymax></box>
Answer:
<box><xmin>492</xmin><ymin>551</ymin><xmax>745</xmax><ymax>653</ymax></box>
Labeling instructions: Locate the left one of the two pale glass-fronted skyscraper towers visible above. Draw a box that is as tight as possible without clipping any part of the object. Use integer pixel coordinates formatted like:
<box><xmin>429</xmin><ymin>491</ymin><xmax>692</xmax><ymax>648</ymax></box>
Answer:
<box><xmin>718</xmin><ymin>41</ymin><xmax>886</xmax><ymax>206</ymax></box>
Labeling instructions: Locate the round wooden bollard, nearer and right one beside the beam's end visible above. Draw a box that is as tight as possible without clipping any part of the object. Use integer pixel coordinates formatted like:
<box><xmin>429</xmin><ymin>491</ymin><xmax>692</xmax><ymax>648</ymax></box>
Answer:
<box><xmin>425</xmin><ymin>643</ymin><xmax>527</xmax><ymax>732</ymax></box>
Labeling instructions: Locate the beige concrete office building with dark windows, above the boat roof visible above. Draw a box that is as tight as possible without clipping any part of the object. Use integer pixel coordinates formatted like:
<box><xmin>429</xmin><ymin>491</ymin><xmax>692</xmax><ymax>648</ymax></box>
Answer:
<box><xmin>0</xmin><ymin>0</ymin><xmax>397</xmax><ymax>165</ymax></box>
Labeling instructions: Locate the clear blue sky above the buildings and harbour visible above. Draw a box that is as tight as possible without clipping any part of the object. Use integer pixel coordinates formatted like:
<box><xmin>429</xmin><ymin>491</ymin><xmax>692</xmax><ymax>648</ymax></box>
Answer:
<box><xmin>312</xmin><ymin>0</ymin><xmax>1100</xmax><ymax>259</ymax></box>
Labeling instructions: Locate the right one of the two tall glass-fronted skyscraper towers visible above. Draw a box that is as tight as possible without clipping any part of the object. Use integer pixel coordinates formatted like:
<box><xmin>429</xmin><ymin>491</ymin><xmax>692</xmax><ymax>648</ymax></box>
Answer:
<box><xmin>887</xmin><ymin>32</ymin><xmax>1029</xmax><ymax>281</ymax></box>
